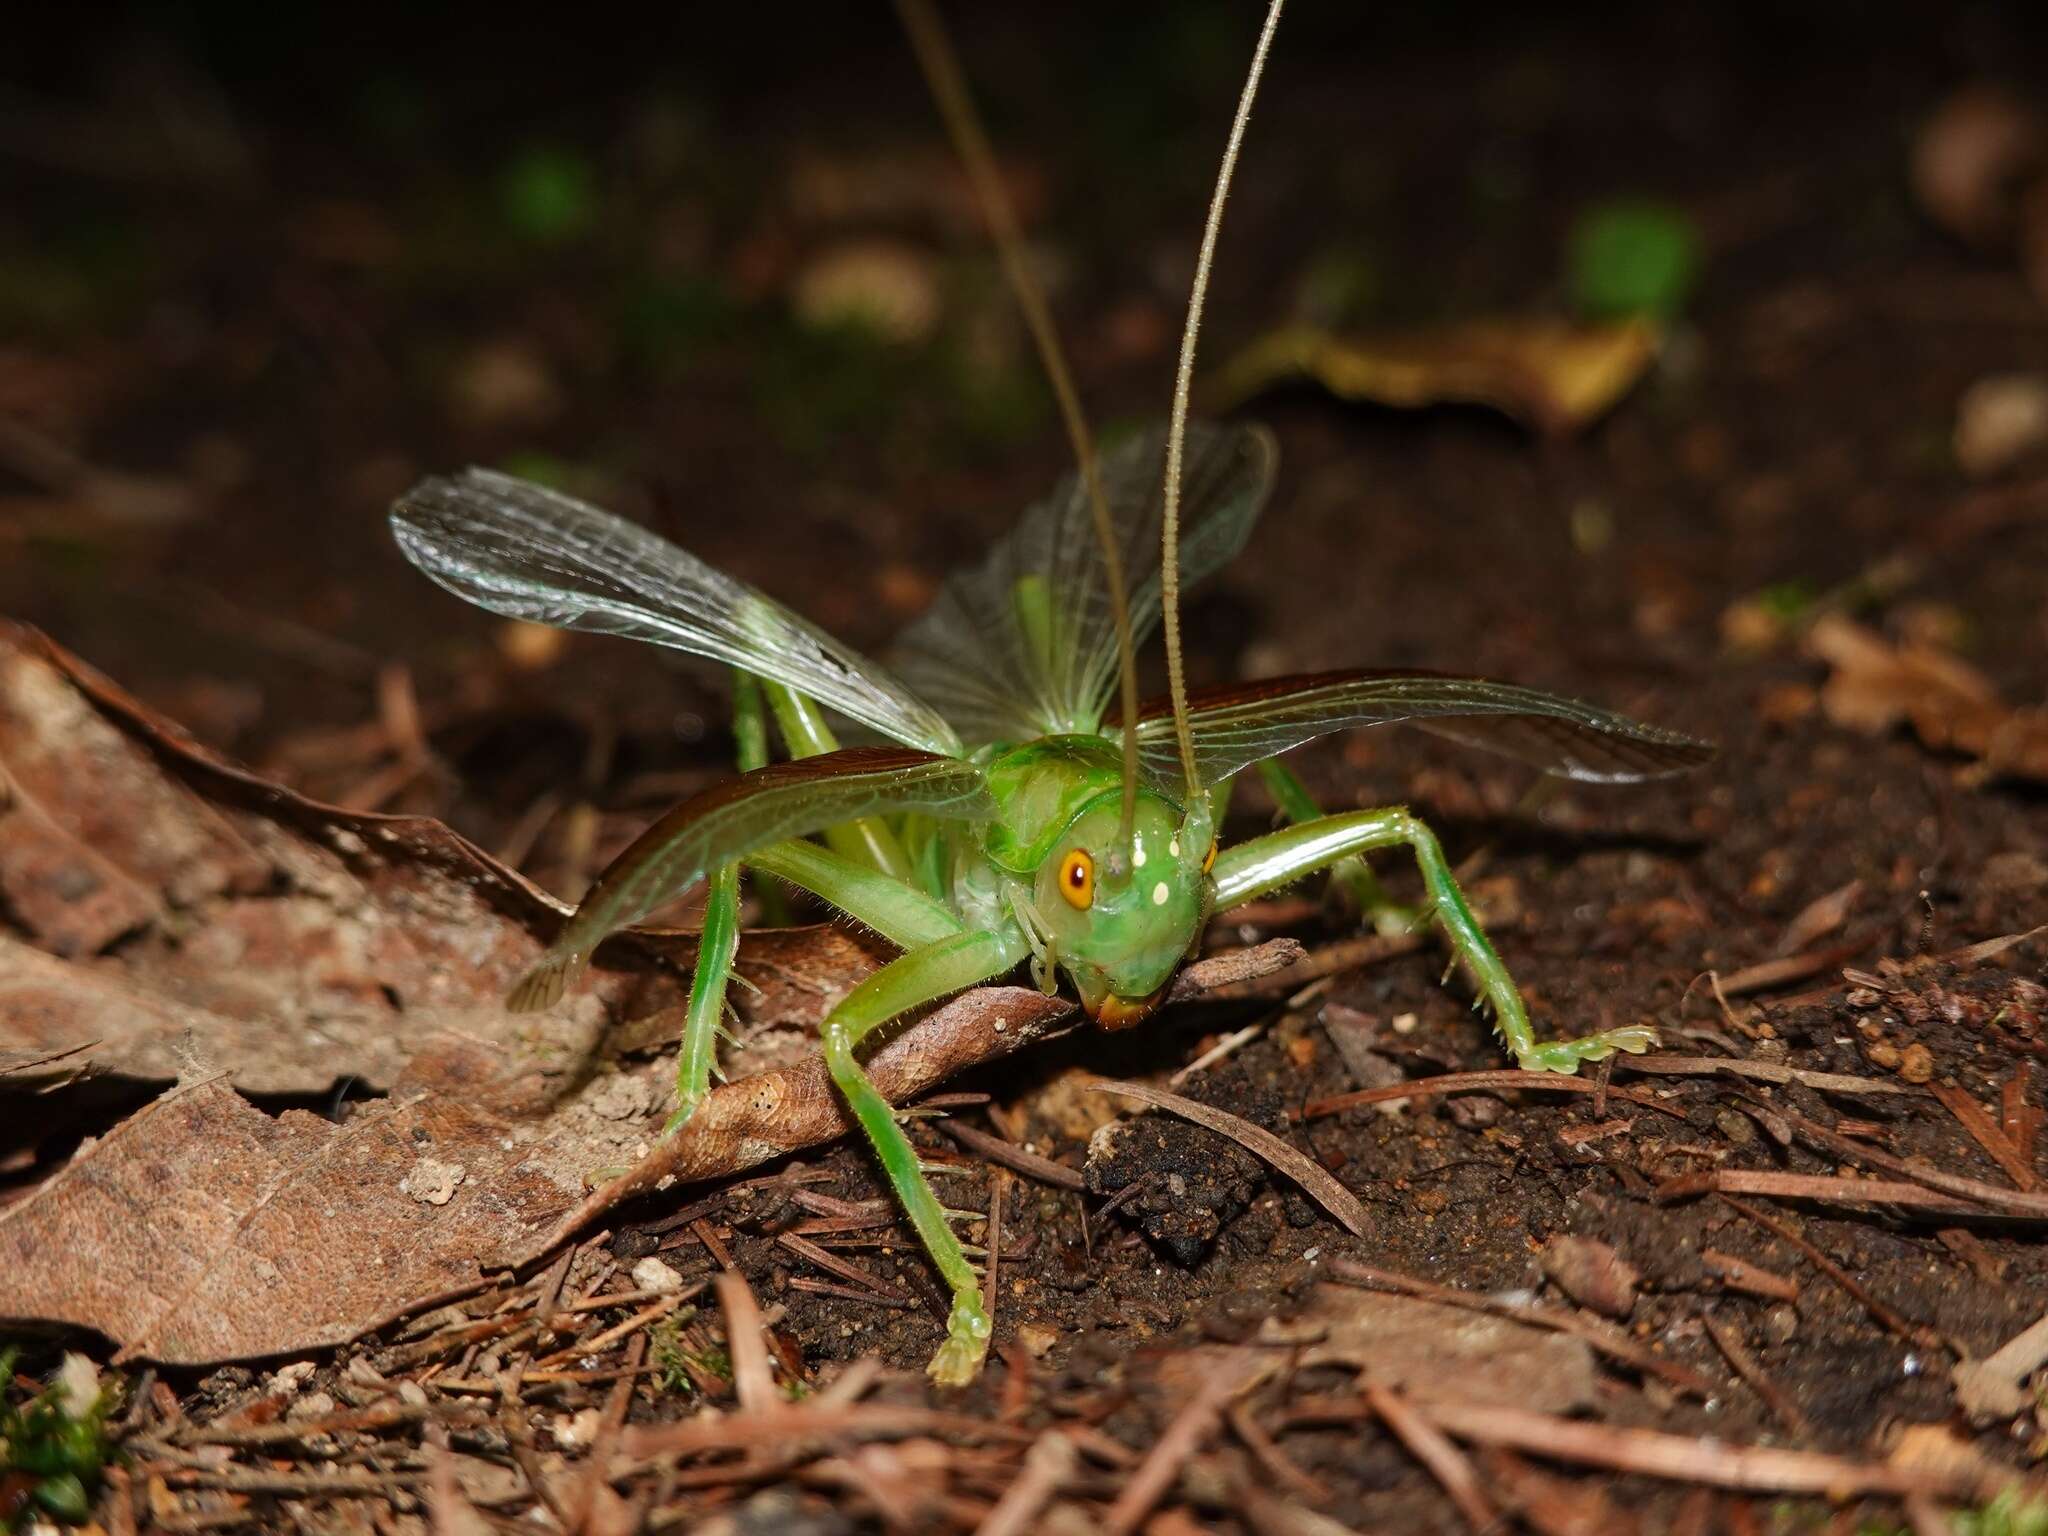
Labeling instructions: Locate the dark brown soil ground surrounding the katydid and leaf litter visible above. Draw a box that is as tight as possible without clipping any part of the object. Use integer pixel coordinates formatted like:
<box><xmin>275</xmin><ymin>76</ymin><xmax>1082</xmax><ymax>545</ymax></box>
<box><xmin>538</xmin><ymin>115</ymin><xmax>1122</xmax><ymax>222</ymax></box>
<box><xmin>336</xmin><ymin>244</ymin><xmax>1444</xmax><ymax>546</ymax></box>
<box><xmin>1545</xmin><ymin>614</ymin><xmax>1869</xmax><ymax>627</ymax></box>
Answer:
<box><xmin>0</xmin><ymin>6</ymin><xmax>2048</xmax><ymax>1530</ymax></box>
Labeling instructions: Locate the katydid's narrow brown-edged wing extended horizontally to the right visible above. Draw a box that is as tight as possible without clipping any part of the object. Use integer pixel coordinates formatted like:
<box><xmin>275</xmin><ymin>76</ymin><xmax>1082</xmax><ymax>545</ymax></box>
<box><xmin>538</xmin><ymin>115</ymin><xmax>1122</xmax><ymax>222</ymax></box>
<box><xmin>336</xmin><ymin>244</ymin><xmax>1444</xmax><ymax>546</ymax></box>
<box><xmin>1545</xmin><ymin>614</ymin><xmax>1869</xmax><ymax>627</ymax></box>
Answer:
<box><xmin>1139</xmin><ymin>672</ymin><xmax>1714</xmax><ymax>784</ymax></box>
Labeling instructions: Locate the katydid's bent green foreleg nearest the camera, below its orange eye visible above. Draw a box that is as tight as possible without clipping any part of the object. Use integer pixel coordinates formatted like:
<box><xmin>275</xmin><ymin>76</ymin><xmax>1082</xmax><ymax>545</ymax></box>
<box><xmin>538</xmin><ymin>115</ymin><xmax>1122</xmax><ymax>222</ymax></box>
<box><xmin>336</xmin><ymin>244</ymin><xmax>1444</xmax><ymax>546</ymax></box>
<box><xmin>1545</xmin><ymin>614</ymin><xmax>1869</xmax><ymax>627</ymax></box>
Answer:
<box><xmin>823</xmin><ymin>932</ymin><xmax>1026</xmax><ymax>1386</ymax></box>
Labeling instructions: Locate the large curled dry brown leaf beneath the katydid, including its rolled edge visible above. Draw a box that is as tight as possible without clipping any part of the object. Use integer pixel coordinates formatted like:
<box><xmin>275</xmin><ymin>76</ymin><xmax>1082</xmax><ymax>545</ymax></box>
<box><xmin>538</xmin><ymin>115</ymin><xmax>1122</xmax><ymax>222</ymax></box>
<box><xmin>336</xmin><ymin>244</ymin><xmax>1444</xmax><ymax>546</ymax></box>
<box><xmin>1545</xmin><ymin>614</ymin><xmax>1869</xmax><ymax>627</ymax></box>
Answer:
<box><xmin>0</xmin><ymin>629</ymin><xmax>1300</xmax><ymax>1364</ymax></box>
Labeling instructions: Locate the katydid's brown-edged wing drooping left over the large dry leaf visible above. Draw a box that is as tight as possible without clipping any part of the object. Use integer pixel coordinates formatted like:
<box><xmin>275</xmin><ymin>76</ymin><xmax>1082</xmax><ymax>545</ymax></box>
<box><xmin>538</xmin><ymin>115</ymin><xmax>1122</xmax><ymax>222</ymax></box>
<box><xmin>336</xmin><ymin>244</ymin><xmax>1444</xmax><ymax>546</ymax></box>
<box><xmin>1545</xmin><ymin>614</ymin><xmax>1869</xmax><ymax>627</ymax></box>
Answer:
<box><xmin>506</xmin><ymin>748</ymin><xmax>995</xmax><ymax>1014</ymax></box>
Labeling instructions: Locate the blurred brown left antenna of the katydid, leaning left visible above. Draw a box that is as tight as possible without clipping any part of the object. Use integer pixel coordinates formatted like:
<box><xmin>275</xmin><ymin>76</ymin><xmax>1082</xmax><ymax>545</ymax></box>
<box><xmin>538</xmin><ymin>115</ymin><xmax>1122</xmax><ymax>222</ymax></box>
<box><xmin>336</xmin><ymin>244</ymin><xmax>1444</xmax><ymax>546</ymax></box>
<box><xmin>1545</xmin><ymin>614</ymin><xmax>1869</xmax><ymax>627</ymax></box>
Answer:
<box><xmin>895</xmin><ymin>0</ymin><xmax>1139</xmax><ymax>846</ymax></box>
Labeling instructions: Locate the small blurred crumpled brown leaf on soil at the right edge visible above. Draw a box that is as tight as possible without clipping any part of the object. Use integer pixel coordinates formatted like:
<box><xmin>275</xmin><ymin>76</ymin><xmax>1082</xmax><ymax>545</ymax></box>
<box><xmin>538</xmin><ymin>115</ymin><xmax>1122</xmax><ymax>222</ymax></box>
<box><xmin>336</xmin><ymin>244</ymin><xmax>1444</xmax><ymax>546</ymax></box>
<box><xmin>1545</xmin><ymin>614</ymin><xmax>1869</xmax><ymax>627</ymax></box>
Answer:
<box><xmin>1806</xmin><ymin>614</ymin><xmax>2048</xmax><ymax>782</ymax></box>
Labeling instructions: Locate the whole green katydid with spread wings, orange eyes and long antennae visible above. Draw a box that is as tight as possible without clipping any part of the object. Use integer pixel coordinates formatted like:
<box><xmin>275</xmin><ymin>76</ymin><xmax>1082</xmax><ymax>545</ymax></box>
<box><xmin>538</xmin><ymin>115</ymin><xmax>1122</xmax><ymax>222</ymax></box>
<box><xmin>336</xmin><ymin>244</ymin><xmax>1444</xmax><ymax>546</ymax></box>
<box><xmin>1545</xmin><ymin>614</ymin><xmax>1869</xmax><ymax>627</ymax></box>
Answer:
<box><xmin>391</xmin><ymin>0</ymin><xmax>1710</xmax><ymax>1384</ymax></box>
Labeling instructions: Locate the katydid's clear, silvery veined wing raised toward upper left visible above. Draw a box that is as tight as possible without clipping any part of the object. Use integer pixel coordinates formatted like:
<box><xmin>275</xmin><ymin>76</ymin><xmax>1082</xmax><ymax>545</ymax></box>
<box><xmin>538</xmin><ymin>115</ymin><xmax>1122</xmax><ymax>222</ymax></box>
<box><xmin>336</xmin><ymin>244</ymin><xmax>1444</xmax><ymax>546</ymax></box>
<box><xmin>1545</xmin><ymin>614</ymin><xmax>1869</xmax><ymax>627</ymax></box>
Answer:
<box><xmin>391</xmin><ymin>469</ymin><xmax>961</xmax><ymax>756</ymax></box>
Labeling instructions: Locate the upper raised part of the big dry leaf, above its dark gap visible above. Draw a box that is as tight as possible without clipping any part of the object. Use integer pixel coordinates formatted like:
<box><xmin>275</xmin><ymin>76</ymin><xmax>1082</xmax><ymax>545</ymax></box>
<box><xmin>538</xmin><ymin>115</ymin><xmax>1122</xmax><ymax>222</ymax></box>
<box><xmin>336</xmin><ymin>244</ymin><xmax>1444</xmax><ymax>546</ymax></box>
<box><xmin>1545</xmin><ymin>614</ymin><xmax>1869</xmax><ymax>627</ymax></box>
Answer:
<box><xmin>0</xmin><ymin>625</ymin><xmax>883</xmax><ymax>1106</ymax></box>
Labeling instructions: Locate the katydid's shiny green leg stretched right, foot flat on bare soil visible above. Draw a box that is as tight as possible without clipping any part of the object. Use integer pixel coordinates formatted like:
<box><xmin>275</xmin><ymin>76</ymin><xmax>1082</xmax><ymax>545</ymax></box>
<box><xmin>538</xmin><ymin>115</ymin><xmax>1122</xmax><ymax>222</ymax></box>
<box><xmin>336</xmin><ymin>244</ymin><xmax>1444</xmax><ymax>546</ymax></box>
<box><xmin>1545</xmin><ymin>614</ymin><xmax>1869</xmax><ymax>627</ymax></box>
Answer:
<box><xmin>1212</xmin><ymin>807</ymin><xmax>1657</xmax><ymax>1073</ymax></box>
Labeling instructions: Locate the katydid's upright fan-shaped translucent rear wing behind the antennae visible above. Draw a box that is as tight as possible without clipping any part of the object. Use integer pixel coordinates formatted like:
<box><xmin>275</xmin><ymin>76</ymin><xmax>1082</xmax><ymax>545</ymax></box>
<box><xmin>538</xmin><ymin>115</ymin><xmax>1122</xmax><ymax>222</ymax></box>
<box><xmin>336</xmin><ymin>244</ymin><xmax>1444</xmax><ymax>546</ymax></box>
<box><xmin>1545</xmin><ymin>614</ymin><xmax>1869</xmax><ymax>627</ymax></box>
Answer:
<box><xmin>891</xmin><ymin>424</ymin><xmax>1278</xmax><ymax>743</ymax></box>
